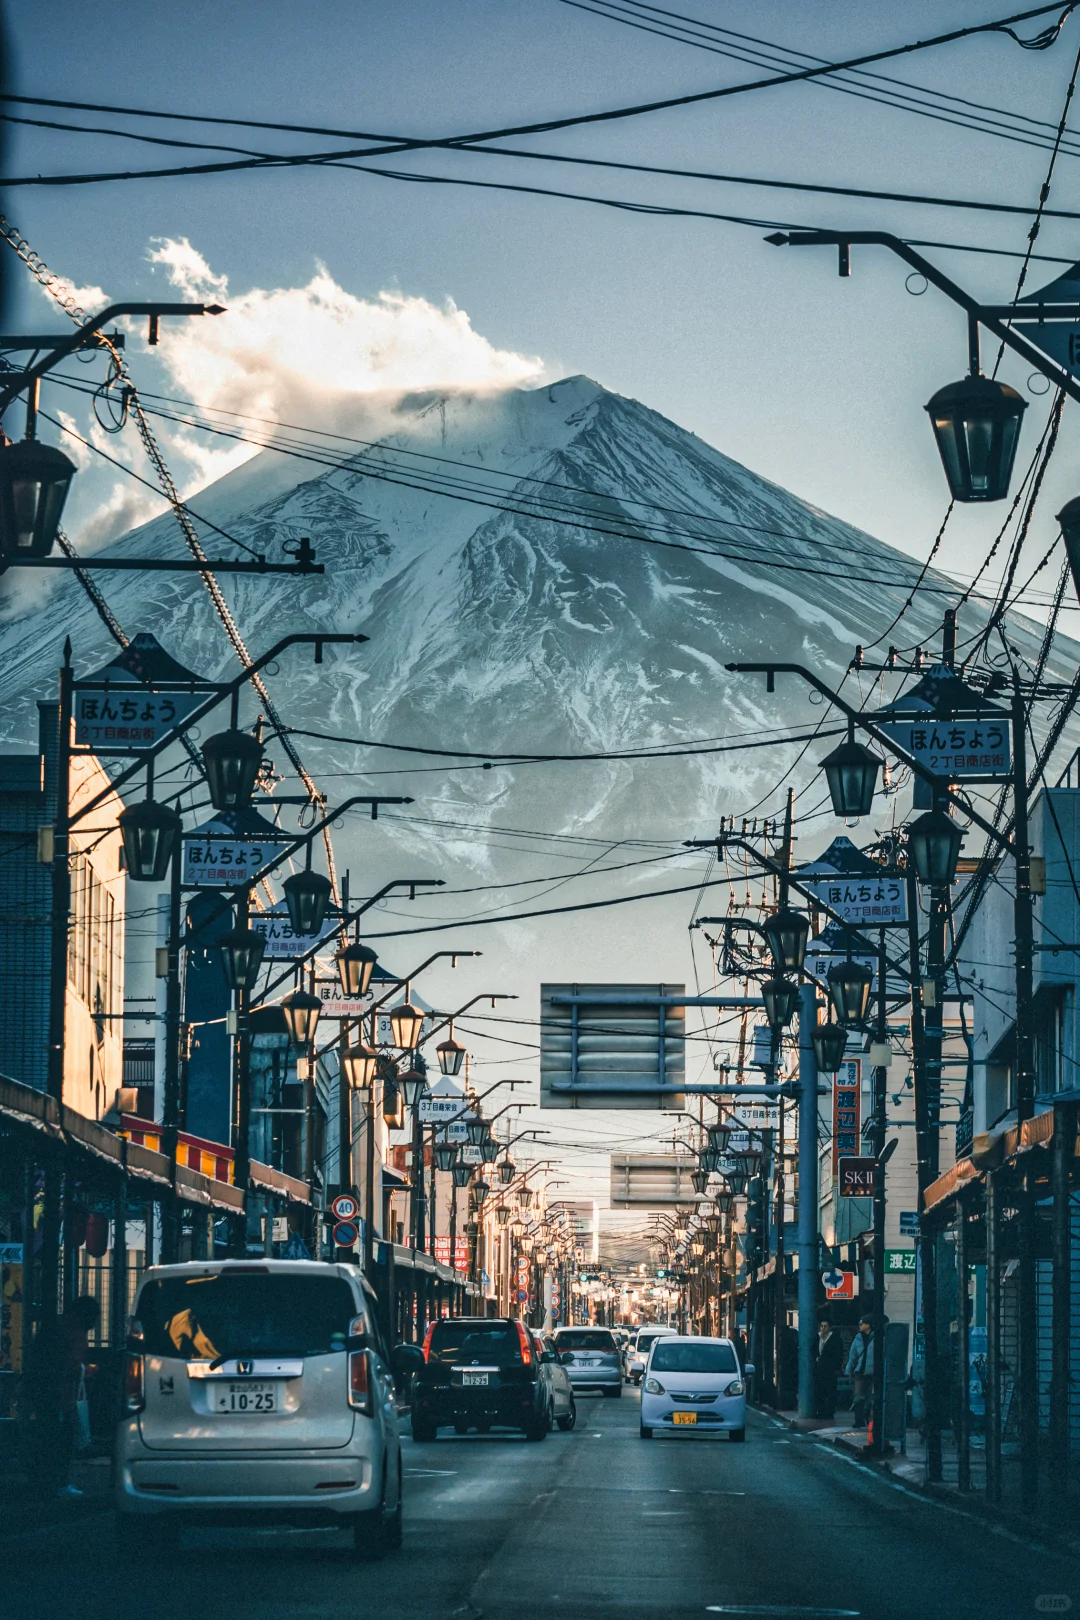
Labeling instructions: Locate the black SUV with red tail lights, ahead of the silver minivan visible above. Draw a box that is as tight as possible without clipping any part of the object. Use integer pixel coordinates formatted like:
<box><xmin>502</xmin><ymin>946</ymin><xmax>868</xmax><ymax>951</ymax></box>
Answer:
<box><xmin>411</xmin><ymin>1317</ymin><xmax>552</xmax><ymax>1440</ymax></box>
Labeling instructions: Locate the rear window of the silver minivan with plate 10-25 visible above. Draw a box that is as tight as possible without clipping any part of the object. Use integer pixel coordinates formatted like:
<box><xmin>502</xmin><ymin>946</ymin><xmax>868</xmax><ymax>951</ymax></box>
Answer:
<box><xmin>136</xmin><ymin>1272</ymin><xmax>359</xmax><ymax>1361</ymax></box>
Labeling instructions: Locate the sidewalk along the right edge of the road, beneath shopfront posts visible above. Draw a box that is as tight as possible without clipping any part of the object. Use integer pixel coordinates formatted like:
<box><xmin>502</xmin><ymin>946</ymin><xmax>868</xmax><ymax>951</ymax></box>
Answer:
<box><xmin>773</xmin><ymin>1406</ymin><xmax>1080</xmax><ymax>1557</ymax></box>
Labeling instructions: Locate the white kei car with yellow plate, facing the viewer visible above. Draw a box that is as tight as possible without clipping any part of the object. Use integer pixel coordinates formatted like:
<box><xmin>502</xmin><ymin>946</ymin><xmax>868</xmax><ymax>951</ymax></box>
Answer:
<box><xmin>641</xmin><ymin>1333</ymin><xmax>753</xmax><ymax>1440</ymax></box>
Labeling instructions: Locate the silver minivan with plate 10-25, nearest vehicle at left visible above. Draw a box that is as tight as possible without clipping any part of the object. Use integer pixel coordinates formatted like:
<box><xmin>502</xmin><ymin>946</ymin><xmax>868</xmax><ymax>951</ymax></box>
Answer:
<box><xmin>113</xmin><ymin>1260</ymin><xmax>402</xmax><ymax>1557</ymax></box>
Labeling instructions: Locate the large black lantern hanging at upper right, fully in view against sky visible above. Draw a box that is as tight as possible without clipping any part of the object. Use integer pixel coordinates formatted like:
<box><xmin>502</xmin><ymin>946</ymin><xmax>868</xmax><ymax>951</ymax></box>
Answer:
<box><xmin>926</xmin><ymin>371</ymin><xmax>1028</xmax><ymax>502</ymax></box>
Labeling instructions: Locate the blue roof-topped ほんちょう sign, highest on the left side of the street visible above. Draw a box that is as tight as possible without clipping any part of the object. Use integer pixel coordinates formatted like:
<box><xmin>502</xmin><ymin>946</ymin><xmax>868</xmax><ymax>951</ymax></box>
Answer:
<box><xmin>71</xmin><ymin>633</ymin><xmax>217</xmax><ymax>755</ymax></box>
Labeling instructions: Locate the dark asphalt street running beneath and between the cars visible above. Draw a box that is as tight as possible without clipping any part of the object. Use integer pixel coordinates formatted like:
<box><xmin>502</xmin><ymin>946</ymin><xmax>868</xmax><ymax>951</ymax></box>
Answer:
<box><xmin>0</xmin><ymin>1390</ymin><xmax>1080</xmax><ymax>1620</ymax></box>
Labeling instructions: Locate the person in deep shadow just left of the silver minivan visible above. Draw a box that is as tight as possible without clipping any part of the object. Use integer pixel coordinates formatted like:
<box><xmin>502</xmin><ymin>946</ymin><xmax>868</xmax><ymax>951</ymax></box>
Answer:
<box><xmin>19</xmin><ymin>1294</ymin><xmax>100</xmax><ymax>1499</ymax></box>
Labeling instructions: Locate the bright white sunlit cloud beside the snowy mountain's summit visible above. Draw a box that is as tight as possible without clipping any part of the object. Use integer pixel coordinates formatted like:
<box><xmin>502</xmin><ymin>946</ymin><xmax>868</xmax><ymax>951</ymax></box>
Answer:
<box><xmin>149</xmin><ymin>238</ymin><xmax>544</xmax><ymax>483</ymax></box>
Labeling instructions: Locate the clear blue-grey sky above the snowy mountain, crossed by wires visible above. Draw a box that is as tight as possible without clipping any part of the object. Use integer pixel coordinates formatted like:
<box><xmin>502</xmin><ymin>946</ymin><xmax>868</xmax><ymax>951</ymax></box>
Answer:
<box><xmin>5</xmin><ymin>0</ymin><xmax>1080</xmax><ymax>627</ymax></box>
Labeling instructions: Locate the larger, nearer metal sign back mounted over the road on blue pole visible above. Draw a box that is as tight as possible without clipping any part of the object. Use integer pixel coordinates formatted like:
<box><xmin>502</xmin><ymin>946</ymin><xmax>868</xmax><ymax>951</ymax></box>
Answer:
<box><xmin>541</xmin><ymin>985</ymin><xmax>687</xmax><ymax>1110</ymax></box>
